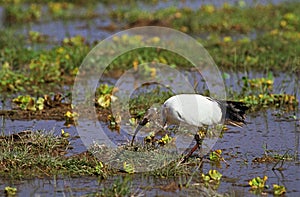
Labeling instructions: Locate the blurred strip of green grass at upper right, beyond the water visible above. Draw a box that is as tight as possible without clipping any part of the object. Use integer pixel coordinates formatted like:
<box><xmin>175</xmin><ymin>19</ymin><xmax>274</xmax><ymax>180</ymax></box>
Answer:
<box><xmin>111</xmin><ymin>2</ymin><xmax>299</xmax><ymax>33</ymax></box>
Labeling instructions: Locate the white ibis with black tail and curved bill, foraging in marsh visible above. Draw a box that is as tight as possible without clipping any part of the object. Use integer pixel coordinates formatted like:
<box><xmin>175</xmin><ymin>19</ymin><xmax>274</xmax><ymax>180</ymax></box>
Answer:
<box><xmin>131</xmin><ymin>94</ymin><xmax>248</xmax><ymax>162</ymax></box>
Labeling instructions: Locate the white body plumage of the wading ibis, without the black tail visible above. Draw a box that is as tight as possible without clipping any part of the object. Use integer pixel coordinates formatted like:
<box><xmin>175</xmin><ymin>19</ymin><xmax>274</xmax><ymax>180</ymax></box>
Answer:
<box><xmin>162</xmin><ymin>94</ymin><xmax>222</xmax><ymax>127</ymax></box>
